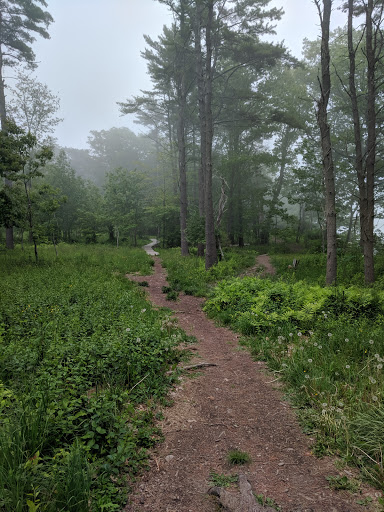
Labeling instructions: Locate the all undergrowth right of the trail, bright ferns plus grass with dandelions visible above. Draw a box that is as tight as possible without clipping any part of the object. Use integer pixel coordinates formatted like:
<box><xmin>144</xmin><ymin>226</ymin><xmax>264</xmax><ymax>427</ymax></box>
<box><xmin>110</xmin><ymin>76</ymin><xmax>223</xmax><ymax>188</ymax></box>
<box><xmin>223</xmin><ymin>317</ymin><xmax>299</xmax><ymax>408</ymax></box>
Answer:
<box><xmin>205</xmin><ymin>274</ymin><xmax>384</xmax><ymax>490</ymax></box>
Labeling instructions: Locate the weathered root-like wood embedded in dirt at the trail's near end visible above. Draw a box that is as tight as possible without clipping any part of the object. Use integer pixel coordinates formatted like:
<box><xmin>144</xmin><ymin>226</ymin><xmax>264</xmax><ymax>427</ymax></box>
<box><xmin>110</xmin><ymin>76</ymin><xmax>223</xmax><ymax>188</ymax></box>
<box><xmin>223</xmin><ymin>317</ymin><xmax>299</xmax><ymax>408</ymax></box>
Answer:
<box><xmin>208</xmin><ymin>475</ymin><xmax>276</xmax><ymax>512</ymax></box>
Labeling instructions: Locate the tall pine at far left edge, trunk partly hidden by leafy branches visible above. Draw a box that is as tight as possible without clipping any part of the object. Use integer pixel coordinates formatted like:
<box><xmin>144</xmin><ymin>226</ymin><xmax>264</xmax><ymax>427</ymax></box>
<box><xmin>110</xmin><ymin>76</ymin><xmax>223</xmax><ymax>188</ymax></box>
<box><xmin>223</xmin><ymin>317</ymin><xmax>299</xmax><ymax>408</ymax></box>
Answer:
<box><xmin>0</xmin><ymin>0</ymin><xmax>53</xmax><ymax>249</ymax></box>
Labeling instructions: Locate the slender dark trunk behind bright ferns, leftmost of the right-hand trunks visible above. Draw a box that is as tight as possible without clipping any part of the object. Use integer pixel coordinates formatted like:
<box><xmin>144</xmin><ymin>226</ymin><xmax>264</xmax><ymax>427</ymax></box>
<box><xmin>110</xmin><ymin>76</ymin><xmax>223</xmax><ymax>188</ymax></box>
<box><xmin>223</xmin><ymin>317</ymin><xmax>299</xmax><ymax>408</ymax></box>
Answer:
<box><xmin>315</xmin><ymin>0</ymin><xmax>337</xmax><ymax>286</ymax></box>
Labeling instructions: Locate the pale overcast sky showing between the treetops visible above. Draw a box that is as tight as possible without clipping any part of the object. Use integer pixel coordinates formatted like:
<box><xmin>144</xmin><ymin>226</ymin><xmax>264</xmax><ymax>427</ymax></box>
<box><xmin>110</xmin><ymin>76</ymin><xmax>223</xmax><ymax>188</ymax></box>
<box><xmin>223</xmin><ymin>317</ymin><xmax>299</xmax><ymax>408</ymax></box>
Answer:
<box><xmin>24</xmin><ymin>0</ymin><xmax>344</xmax><ymax>148</ymax></box>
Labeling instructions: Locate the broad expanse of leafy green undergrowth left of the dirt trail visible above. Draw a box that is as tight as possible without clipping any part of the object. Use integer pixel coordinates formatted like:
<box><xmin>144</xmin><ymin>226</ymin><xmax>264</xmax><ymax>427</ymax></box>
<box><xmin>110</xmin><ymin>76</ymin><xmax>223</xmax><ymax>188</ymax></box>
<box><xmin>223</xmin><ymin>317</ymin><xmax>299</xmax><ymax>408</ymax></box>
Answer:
<box><xmin>0</xmin><ymin>246</ymin><xmax>192</xmax><ymax>512</ymax></box>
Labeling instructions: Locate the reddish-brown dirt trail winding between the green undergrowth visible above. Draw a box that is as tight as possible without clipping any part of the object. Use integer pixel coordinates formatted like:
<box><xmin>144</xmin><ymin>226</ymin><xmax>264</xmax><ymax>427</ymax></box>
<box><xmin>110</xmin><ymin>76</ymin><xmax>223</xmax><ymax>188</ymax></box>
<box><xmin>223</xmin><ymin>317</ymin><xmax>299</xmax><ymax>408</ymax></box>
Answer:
<box><xmin>125</xmin><ymin>257</ymin><xmax>372</xmax><ymax>512</ymax></box>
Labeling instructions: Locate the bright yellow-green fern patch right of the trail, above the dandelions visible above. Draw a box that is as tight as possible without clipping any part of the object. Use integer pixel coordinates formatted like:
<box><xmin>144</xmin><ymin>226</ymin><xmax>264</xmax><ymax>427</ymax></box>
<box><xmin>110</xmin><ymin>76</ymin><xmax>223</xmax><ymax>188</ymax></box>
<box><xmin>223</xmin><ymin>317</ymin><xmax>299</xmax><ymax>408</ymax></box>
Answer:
<box><xmin>205</xmin><ymin>277</ymin><xmax>384</xmax><ymax>334</ymax></box>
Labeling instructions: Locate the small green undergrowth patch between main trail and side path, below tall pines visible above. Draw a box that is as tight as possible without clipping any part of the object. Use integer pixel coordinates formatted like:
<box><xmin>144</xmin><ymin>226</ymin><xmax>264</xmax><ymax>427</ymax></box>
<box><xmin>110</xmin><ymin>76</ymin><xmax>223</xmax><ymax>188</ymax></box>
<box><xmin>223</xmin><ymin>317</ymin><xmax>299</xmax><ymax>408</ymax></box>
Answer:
<box><xmin>160</xmin><ymin>248</ymin><xmax>256</xmax><ymax>297</ymax></box>
